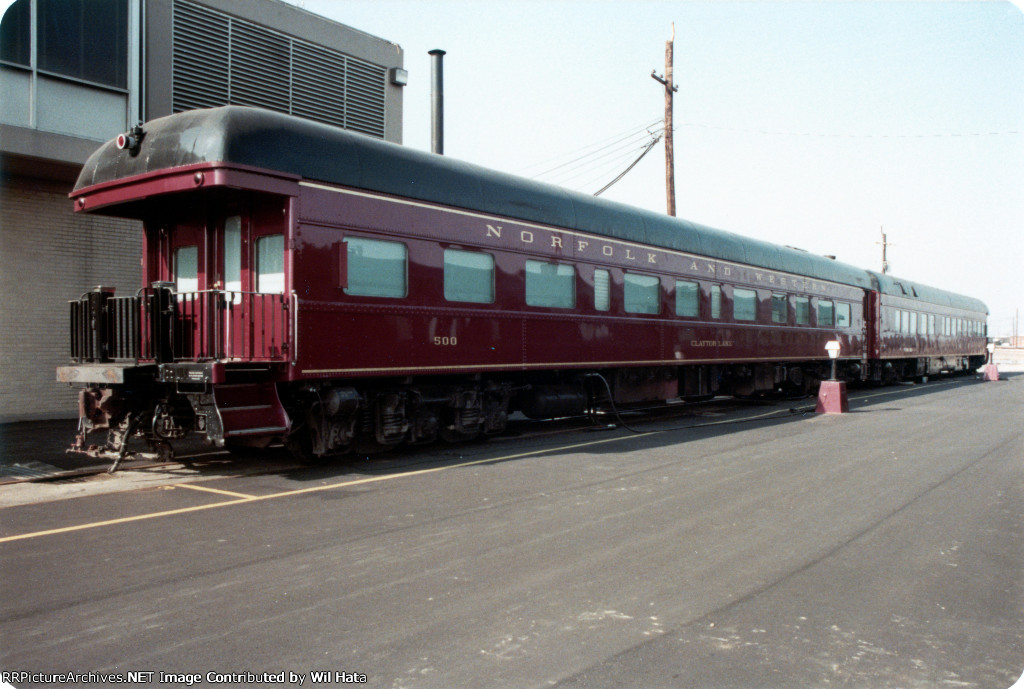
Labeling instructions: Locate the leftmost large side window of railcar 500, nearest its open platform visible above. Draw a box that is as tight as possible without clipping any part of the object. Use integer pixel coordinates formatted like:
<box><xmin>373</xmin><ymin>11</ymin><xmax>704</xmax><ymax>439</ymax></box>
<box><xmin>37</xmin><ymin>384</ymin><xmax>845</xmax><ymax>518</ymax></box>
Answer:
<box><xmin>345</xmin><ymin>236</ymin><xmax>409</xmax><ymax>299</ymax></box>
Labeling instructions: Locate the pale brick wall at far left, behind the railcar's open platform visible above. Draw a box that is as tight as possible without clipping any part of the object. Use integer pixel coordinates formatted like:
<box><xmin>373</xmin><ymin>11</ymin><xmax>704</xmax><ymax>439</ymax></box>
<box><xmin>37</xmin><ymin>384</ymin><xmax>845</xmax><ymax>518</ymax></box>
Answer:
<box><xmin>0</xmin><ymin>179</ymin><xmax>142</xmax><ymax>423</ymax></box>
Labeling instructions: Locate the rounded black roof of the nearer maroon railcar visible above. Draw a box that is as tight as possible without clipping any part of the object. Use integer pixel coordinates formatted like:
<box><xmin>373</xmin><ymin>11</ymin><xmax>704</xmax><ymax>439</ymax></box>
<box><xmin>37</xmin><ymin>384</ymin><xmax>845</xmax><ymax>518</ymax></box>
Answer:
<box><xmin>75</xmin><ymin>105</ymin><xmax>980</xmax><ymax>311</ymax></box>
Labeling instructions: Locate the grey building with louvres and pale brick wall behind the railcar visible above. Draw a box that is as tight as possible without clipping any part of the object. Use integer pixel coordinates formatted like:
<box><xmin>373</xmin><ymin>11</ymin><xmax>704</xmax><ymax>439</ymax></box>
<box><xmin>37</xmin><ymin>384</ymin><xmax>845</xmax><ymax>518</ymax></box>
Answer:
<box><xmin>0</xmin><ymin>0</ymin><xmax>406</xmax><ymax>423</ymax></box>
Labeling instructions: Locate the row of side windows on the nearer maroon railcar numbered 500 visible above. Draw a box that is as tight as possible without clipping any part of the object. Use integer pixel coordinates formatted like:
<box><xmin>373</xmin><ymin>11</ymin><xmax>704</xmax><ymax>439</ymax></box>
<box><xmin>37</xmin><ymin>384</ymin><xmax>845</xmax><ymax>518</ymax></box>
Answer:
<box><xmin>344</xmin><ymin>236</ymin><xmax>851</xmax><ymax>328</ymax></box>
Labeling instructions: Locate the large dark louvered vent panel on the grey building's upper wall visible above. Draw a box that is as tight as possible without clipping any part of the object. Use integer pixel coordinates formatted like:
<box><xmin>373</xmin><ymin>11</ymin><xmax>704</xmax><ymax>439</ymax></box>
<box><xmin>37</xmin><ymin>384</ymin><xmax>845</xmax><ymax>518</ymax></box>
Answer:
<box><xmin>171</xmin><ymin>0</ymin><xmax>387</xmax><ymax>138</ymax></box>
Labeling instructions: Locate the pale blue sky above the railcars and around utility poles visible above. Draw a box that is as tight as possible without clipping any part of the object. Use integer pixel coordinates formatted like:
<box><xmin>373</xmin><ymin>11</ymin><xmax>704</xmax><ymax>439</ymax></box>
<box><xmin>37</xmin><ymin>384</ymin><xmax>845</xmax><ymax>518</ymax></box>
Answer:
<box><xmin>293</xmin><ymin>0</ymin><xmax>1024</xmax><ymax>334</ymax></box>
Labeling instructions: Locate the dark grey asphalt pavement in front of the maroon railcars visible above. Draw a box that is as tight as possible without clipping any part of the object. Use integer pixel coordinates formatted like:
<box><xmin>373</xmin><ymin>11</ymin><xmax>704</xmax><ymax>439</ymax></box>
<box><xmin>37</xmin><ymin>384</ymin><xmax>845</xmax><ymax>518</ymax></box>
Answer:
<box><xmin>0</xmin><ymin>375</ymin><xmax>1024</xmax><ymax>689</ymax></box>
